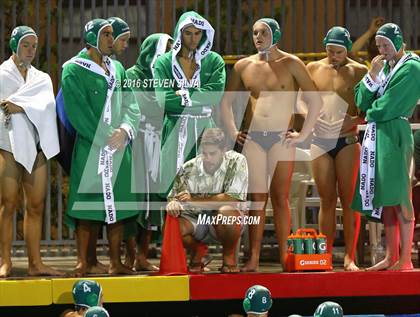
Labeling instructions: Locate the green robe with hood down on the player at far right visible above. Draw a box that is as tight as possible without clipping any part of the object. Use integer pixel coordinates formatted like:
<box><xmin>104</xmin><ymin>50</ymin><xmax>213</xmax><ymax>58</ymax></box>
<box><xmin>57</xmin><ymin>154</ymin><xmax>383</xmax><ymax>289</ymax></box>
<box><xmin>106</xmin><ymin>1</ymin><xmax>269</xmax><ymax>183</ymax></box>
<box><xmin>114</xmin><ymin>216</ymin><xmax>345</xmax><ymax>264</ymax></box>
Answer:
<box><xmin>351</xmin><ymin>53</ymin><xmax>420</xmax><ymax>221</ymax></box>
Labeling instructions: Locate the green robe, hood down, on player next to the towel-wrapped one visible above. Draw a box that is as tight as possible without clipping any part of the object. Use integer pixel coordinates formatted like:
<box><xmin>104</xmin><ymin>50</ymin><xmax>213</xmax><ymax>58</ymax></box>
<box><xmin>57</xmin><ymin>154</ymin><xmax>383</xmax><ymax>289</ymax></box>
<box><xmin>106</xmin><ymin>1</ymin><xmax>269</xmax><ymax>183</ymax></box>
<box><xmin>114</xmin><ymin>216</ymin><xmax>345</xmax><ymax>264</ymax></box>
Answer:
<box><xmin>61</xmin><ymin>51</ymin><xmax>140</xmax><ymax>228</ymax></box>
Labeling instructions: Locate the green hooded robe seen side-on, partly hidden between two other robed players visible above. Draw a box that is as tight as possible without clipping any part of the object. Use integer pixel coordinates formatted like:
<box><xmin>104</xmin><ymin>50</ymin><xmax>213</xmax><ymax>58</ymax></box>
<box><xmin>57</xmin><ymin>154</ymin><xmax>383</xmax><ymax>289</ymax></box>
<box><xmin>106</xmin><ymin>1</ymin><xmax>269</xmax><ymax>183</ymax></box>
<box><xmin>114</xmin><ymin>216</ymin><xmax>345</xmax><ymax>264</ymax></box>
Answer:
<box><xmin>126</xmin><ymin>33</ymin><xmax>172</xmax><ymax>236</ymax></box>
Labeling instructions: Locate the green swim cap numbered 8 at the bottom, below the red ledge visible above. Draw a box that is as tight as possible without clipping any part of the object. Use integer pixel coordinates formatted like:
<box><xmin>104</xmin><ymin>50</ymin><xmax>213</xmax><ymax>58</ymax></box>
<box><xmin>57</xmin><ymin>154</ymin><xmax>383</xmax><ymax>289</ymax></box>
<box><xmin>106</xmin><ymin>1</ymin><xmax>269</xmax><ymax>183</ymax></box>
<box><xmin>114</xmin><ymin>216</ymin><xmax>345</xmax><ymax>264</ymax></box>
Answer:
<box><xmin>243</xmin><ymin>285</ymin><xmax>273</xmax><ymax>314</ymax></box>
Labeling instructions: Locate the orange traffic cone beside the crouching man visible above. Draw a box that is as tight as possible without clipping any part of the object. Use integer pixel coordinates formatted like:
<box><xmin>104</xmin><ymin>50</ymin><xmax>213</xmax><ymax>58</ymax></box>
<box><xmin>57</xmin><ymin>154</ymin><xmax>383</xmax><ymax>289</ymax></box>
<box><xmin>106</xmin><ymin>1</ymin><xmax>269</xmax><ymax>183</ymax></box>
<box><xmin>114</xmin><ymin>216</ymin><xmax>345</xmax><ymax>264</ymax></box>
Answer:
<box><xmin>159</xmin><ymin>214</ymin><xmax>187</xmax><ymax>275</ymax></box>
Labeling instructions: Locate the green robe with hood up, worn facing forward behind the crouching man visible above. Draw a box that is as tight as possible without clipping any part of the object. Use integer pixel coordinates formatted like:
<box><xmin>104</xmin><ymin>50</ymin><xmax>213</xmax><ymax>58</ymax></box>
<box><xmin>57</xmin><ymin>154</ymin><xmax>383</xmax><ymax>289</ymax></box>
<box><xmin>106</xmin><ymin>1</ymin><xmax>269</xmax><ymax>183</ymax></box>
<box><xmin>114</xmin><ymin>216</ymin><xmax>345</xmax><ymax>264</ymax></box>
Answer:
<box><xmin>155</xmin><ymin>11</ymin><xmax>226</xmax><ymax>198</ymax></box>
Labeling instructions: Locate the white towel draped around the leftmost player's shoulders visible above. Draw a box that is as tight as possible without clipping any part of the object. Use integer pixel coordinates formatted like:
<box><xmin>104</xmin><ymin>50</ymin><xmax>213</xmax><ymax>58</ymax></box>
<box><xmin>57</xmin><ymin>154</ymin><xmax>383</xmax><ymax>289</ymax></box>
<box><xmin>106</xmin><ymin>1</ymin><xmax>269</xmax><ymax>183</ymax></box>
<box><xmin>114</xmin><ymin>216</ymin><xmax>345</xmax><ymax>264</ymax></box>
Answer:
<box><xmin>0</xmin><ymin>58</ymin><xmax>60</xmax><ymax>173</ymax></box>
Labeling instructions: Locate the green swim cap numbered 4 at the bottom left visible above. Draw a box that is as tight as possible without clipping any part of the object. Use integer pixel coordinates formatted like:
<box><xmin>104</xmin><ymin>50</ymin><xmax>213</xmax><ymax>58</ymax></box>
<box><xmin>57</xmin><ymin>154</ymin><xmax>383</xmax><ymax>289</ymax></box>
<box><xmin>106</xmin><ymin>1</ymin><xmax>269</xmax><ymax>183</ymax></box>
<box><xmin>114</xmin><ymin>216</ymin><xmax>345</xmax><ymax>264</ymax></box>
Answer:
<box><xmin>72</xmin><ymin>280</ymin><xmax>102</xmax><ymax>307</ymax></box>
